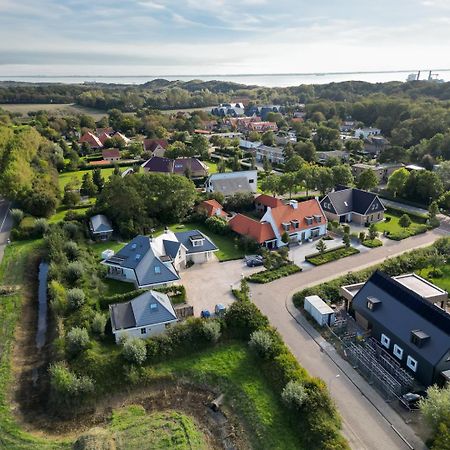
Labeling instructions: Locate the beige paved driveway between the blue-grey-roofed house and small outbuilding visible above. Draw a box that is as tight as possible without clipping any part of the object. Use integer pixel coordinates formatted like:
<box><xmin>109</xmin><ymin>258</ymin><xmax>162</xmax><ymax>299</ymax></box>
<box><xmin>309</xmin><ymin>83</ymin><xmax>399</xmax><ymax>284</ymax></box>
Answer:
<box><xmin>181</xmin><ymin>255</ymin><xmax>264</xmax><ymax>316</ymax></box>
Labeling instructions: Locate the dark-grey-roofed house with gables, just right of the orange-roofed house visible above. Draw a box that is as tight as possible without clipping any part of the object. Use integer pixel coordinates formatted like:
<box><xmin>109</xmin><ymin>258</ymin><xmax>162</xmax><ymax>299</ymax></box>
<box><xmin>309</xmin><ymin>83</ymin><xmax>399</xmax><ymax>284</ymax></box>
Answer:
<box><xmin>320</xmin><ymin>187</ymin><xmax>385</xmax><ymax>225</ymax></box>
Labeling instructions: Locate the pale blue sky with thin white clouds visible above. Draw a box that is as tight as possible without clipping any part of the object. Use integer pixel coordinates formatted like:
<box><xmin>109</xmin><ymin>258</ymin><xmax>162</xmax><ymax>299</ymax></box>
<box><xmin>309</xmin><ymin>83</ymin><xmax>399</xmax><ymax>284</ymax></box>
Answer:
<box><xmin>0</xmin><ymin>0</ymin><xmax>450</xmax><ymax>76</ymax></box>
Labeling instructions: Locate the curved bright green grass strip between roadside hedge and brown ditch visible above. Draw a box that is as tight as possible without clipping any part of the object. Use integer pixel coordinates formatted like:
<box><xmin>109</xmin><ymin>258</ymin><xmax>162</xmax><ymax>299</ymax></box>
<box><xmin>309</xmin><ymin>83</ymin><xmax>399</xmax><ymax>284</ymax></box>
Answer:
<box><xmin>155</xmin><ymin>343</ymin><xmax>302</xmax><ymax>450</ymax></box>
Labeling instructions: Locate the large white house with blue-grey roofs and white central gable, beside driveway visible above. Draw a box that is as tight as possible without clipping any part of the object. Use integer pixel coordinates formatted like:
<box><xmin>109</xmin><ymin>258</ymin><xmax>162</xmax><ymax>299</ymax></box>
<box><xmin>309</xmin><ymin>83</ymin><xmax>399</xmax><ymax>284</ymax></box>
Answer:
<box><xmin>102</xmin><ymin>230</ymin><xmax>218</xmax><ymax>289</ymax></box>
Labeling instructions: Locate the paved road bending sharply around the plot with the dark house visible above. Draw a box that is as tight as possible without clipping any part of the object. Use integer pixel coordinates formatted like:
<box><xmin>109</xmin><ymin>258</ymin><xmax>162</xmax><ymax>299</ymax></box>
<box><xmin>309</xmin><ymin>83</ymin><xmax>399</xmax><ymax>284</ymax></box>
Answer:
<box><xmin>251</xmin><ymin>229</ymin><xmax>448</xmax><ymax>450</ymax></box>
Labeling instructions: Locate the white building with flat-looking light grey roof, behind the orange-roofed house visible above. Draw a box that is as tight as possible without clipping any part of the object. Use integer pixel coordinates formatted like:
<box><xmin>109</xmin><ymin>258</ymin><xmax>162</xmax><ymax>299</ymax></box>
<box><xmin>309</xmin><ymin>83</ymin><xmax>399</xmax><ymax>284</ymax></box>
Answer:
<box><xmin>205</xmin><ymin>170</ymin><xmax>258</xmax><ymax>196</ymax></box>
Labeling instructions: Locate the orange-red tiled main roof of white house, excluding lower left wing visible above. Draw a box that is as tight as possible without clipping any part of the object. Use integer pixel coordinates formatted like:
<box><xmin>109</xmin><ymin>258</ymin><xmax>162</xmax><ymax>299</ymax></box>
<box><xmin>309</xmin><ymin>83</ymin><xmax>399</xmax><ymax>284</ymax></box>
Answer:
<box><xmin>271</xmin><ymin>199</ymin><xmax>327</xmax><ymax>234</ymax></box>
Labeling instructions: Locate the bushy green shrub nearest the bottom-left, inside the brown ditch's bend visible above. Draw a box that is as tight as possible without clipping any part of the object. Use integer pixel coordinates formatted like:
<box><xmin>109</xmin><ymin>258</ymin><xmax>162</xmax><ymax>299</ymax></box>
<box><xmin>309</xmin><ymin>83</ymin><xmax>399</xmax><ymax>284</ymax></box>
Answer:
<box><xmin>49</xmin><ymin>363</ymin><xmax>94</xmax><ymax>414</ymax></box>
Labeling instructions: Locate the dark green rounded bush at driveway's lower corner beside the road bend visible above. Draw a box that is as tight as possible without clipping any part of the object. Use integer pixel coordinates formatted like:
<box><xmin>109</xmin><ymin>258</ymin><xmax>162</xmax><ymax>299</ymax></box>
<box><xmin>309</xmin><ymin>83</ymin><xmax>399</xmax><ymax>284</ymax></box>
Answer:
<box><xmin>225</xmin><ymin>302</ymin><xmax>269</xmax><ymax>340</ymax></box>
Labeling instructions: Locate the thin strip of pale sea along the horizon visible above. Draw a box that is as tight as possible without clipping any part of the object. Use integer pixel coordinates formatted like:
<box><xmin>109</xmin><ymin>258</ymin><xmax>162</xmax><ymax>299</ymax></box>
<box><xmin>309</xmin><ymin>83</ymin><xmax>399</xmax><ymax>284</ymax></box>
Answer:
<box><xmin>0</xmin><ymin>69</ymin><xmax>450</xmax><ymax>87</ymax></box>
